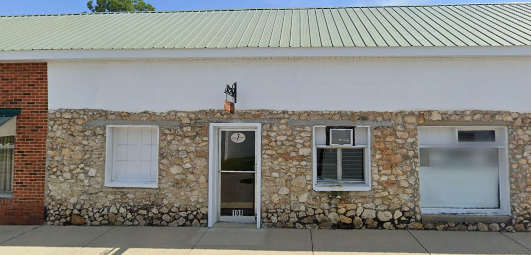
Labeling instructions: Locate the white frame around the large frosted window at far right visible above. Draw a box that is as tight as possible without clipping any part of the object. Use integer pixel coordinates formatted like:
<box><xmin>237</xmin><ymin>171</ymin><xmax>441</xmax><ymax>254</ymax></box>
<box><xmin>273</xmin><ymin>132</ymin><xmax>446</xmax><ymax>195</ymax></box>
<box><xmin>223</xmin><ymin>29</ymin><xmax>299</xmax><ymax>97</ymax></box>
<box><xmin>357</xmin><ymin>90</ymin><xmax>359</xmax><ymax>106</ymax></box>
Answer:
<box><xmin>419</xmin><ymin>126</ymin><xmax>511</xmax><ymax>215</ymax></box>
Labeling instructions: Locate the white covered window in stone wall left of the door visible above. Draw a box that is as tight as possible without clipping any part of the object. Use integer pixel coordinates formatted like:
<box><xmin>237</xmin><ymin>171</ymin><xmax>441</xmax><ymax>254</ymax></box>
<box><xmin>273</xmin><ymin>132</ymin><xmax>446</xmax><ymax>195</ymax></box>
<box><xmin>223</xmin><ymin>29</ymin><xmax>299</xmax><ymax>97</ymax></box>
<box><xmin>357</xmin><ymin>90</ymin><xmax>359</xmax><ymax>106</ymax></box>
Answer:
<box><xmin>105</xmin><ymin>126</ymin><xmax>159</xmax><ymax>188</ymax></box>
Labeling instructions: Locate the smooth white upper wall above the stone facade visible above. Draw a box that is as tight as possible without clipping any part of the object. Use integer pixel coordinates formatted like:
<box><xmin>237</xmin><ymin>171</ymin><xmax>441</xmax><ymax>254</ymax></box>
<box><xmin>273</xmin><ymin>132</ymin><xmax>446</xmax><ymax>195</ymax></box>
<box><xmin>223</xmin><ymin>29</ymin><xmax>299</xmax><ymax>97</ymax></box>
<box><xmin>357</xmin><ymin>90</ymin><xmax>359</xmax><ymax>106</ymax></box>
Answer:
<box><xmin>48</xmin><ymin>57</ymin><xmax>531</xmax><ymax>112</ymax></box>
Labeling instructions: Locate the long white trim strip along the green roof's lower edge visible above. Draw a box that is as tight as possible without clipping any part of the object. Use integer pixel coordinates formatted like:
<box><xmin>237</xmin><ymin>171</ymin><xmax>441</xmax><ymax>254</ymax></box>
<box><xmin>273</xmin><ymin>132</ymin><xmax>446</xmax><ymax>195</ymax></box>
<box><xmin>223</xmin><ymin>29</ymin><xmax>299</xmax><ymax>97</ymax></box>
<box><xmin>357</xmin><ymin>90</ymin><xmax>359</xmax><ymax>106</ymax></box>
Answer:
<box><xmin>0</xmin><ymin>46</ymin><xmax>531</xmax><ymax>62</ymax></box>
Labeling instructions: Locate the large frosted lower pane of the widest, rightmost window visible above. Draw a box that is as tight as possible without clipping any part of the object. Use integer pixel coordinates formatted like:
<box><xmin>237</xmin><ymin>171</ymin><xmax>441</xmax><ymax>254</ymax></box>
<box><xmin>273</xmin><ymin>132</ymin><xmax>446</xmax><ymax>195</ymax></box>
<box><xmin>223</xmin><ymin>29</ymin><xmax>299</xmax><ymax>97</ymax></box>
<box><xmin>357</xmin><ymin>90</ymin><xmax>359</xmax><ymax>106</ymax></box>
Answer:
<box><xmin>420</xmin><ymin>148</ymin><xmax>500</xmax><ymax>209</ymax></box>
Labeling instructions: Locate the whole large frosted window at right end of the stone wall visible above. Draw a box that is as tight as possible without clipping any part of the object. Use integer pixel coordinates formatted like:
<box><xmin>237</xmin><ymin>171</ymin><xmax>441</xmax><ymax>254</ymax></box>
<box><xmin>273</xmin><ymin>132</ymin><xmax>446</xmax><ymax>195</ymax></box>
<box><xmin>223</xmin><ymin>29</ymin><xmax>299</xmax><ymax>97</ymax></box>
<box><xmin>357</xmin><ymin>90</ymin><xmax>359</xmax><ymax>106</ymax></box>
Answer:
<box><xmin>419</xmin><ymin>127</ymin><xmax>509</xmax><ymax>214</ymax></box>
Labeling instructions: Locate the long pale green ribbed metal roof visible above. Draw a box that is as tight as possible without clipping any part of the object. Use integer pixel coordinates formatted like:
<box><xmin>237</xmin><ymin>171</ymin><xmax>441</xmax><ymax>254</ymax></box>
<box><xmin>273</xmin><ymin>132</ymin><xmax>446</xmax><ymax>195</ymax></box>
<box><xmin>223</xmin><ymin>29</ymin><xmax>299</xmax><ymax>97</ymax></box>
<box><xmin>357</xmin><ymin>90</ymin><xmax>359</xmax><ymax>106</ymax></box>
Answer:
<box><xmin>0</xmin><ymin>3</ymin><xmax>531</xmax><ymax>51</ymax></box>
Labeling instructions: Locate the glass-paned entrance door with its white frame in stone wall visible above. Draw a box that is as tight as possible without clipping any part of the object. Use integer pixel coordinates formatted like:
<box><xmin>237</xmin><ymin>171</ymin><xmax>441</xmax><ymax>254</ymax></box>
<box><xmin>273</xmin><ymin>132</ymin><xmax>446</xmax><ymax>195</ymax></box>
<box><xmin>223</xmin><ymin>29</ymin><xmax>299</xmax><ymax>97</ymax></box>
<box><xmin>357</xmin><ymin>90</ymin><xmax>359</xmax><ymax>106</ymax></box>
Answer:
<box><xmin>208</xmin><ymin>123</ymin><xmax>261</xmax><ymax>228</ymax></box>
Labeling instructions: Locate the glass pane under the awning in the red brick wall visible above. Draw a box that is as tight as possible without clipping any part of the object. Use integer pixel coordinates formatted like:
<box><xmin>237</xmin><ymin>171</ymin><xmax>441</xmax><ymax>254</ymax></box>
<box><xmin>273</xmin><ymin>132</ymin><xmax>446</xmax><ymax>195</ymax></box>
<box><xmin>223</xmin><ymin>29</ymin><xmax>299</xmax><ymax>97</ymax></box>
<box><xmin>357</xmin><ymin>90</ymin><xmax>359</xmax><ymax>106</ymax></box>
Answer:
<box><xmin>0</xmin><ymin>136</ymin><xmax>15</xmax><ymax>193</ymax></box>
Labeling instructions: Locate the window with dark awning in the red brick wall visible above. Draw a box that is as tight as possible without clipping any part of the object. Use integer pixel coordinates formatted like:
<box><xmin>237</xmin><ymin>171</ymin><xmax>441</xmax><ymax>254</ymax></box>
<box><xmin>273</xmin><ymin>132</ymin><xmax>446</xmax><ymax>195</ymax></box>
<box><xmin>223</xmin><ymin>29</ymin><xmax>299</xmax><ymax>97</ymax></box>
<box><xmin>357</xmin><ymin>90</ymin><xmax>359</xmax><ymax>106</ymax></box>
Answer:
<box><xmin>0</xmin><ymin>109</ymin><xmax>20</xmax><ymax>197</ymax></box>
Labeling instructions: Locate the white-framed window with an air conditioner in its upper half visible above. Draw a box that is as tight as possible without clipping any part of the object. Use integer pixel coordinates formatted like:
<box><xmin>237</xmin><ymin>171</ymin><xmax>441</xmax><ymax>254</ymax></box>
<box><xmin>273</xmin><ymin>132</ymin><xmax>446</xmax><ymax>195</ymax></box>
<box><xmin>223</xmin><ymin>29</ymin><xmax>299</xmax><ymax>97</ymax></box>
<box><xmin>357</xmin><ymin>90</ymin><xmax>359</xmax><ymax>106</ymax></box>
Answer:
<box><xmin>313</xmin><ymin>126</ymin><xmax>370</xmax><ymax>191</ymax></box>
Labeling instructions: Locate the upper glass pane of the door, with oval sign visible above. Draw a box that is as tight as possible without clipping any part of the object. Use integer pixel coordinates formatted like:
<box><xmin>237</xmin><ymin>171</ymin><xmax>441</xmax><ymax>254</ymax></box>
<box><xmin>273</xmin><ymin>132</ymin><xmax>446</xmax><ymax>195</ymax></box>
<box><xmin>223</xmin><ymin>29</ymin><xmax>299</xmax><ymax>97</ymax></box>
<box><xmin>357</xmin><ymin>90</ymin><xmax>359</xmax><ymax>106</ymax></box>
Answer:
<box><xmin>221</xmin><ymin>131</ymin><xmax>255</xmax><ymax>171</ymax></box>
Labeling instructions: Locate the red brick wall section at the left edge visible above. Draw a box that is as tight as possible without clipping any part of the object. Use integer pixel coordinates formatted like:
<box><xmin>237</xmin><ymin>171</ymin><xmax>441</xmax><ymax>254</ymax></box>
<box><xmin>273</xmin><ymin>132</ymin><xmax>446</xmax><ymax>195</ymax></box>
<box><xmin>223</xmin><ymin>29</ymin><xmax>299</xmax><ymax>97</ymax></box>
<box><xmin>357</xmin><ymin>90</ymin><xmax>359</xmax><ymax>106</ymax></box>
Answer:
<box><xmin>0</xmin><ymin>63</ymin><xmax>48</xmax><ymax>225</ymax></box>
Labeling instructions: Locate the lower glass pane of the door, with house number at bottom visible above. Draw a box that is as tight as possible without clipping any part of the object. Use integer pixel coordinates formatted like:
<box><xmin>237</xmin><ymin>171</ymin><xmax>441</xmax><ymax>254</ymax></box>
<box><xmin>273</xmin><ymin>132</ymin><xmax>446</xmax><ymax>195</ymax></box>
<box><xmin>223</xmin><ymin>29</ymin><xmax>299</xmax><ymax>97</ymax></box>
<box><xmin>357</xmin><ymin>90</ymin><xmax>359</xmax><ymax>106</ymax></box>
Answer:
<box><xmin>221</xmin><ymin>173</ymin><xmax>255</xmax><ymax>216</ymax></box>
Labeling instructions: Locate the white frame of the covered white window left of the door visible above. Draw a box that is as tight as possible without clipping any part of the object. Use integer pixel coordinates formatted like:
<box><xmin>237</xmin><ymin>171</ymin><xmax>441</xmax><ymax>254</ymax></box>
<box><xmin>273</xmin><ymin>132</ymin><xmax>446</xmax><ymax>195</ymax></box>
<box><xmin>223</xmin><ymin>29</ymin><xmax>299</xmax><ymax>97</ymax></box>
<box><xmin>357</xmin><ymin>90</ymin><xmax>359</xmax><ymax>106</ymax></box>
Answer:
<box><xmin>105</xmin><ymin>125</ymin><xmax>160</xmax><ymax>188</ymax></box>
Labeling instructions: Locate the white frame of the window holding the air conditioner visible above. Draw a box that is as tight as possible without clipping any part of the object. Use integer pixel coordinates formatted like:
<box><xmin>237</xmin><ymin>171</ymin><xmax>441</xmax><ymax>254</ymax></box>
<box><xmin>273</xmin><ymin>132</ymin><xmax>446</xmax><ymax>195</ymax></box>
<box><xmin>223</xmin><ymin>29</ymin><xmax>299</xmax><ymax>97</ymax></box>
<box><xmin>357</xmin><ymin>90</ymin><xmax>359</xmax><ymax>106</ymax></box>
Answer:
<box><xmin>312</xmin><ymin>125</ymin><xmax>372</xmax><ymax>191</ymax></box>
